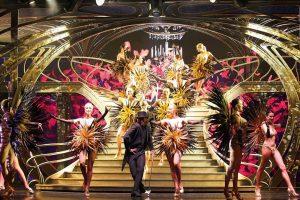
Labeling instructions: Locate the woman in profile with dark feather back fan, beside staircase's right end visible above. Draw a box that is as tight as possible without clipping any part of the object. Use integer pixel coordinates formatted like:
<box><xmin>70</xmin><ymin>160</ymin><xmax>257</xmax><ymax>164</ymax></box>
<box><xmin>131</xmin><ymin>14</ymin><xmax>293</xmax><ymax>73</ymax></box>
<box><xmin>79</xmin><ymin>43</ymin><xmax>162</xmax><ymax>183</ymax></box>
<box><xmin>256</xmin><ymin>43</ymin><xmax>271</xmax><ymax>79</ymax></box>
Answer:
<box><xmin>208</xmin><ymin>87</ymin><xmax>247</xmax><ymax>199</ymax></box>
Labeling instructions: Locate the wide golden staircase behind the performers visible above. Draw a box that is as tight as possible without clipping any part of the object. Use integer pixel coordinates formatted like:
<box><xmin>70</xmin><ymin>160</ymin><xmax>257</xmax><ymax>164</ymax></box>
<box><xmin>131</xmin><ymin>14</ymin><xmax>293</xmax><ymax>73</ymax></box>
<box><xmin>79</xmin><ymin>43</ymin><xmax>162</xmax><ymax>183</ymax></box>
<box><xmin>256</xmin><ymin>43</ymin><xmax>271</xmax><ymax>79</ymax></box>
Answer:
<box><xmin>36</xmin><ymin>100</ymin><xmax>252</xmax><ymax>192</ymax></box>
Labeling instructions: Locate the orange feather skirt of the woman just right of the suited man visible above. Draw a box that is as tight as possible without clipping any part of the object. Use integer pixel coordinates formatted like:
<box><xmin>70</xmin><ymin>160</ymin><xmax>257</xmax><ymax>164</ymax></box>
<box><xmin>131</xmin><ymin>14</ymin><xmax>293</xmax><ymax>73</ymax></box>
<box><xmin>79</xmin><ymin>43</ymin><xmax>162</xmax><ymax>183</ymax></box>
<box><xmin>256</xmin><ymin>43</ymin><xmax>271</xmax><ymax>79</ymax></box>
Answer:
<box><xmin>153</xmin><ymin>126</ymin><xmax>197</xmax><ymax>156</ymax></box>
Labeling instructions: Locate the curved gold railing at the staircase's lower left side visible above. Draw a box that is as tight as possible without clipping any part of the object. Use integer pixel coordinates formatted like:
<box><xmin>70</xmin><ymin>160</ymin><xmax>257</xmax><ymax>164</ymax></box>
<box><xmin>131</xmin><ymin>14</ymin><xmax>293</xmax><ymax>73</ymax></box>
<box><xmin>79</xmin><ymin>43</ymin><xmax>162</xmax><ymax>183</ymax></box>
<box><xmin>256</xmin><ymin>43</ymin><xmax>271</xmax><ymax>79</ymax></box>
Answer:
<box><xmin>26</xmin><ymin>142</ymin><xmax>78</xmax><ymax>185</ymax></box>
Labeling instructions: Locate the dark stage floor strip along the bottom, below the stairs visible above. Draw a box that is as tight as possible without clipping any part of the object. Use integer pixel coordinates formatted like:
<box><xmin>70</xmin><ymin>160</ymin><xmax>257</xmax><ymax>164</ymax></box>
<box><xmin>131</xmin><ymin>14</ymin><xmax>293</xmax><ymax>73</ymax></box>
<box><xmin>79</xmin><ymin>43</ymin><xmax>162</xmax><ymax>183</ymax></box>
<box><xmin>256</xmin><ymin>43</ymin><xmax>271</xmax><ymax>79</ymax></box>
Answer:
<box><xmin>2</xmin><ymin>189</ymin><xmax>300</xmax><ymax>200</ymax></box>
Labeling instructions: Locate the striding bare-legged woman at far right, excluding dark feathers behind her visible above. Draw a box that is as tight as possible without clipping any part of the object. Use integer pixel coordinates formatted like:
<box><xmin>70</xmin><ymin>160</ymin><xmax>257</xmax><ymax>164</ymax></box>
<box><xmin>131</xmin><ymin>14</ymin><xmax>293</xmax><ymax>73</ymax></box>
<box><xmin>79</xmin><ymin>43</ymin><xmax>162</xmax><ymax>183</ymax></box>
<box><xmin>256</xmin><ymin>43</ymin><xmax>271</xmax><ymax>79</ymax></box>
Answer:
<box><xmin>255</xmin><ymin>110</ymin><xmax>299</xmax><ymax>197</ymax></box>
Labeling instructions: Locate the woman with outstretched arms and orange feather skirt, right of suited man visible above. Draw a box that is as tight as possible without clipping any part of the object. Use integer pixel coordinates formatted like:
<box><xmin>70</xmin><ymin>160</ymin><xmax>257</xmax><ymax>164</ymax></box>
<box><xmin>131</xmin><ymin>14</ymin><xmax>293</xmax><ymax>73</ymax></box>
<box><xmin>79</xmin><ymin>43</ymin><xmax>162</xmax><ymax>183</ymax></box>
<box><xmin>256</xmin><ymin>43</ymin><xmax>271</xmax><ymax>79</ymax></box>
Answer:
<box><xmin>151</xmin><ymin>104</ymin><xmax>202</xmax><ymax>197</ymax></box>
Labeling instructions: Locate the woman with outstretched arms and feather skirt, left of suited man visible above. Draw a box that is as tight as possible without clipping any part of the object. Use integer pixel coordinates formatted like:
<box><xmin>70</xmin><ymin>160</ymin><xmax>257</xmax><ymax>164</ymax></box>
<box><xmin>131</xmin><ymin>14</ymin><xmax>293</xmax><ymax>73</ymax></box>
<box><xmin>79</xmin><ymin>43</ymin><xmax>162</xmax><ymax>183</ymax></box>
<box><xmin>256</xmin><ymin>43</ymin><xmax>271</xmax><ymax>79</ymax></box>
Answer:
<box><xmin>53</xmin><ymin>103</ymin><xmax>110</xmax><ymax>197</ymax></box>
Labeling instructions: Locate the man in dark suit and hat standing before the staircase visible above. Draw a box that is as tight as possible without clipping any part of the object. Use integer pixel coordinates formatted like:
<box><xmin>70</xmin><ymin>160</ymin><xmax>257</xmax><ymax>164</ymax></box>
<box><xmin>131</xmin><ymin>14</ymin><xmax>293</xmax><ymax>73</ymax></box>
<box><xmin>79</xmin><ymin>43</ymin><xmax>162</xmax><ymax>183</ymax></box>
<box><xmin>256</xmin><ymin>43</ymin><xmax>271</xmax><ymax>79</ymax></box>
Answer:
<box><xmin>122</xmin><ymin>111</ymin><xmax>154</xmax><ymax>197</ymax></box>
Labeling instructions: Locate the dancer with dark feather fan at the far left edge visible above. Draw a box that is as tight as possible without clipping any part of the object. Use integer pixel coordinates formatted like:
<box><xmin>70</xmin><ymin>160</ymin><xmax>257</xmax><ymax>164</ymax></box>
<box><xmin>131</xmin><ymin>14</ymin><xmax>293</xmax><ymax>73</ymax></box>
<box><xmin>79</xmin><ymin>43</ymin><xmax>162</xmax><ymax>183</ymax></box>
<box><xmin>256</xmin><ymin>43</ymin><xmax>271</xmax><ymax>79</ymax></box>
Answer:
<box><xmin>1</xmin><ymin>88</ymin><xmax>50</xmax><ymax>195</ymax></box>
